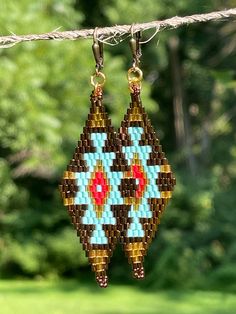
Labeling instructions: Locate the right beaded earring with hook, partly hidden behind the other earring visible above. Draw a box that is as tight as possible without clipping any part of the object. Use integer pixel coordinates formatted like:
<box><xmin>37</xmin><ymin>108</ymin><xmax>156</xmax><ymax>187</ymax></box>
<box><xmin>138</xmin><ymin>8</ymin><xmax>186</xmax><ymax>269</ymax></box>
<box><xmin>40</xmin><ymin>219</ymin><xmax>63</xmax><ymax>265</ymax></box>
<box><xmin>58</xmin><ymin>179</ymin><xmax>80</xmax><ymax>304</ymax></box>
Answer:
<box><xmin>118</xmin><ymin>32</ymin><xmax>176</xmax><ymax>279</ymax></box>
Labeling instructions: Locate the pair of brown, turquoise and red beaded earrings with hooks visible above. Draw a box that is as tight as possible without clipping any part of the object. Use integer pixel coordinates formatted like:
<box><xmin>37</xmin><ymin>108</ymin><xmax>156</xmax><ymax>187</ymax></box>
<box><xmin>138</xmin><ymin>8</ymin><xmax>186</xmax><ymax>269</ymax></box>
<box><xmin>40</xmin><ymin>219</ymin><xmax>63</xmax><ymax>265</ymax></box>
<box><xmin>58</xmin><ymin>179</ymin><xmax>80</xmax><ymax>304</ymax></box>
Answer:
<box><xmin>60</xmin><ymin>33</ymin><xmax>175</xmax><ymax>287</ymax></box>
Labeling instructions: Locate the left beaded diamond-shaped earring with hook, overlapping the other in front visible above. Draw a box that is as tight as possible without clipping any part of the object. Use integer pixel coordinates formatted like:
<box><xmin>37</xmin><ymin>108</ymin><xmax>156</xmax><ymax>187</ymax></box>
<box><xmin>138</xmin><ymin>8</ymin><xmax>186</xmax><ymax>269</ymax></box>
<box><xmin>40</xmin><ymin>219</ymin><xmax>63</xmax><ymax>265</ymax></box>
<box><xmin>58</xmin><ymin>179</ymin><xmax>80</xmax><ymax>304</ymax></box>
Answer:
<box><xmin>60</xmin><ymin>30</ymin><xmax>122</xmax><ymax>287</ymax></box>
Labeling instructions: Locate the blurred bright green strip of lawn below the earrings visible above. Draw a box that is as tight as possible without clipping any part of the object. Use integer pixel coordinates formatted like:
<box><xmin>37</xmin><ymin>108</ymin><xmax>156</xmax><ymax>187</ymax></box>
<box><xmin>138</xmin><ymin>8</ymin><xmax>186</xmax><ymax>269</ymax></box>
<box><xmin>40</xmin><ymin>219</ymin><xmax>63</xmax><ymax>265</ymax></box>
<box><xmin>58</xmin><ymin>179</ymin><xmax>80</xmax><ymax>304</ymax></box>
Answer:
<box><xmin>0</xmin><ymin>281</ymin><xmax>236</xmax><ymax>314</ymax></box>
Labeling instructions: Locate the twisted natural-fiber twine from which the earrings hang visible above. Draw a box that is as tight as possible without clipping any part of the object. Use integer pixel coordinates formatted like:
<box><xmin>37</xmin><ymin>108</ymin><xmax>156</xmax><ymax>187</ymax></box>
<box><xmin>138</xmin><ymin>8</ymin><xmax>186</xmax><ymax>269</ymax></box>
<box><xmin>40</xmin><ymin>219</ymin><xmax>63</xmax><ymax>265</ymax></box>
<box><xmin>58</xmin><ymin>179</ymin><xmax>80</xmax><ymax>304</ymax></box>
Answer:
<box><xmin>0</xmin><ymin>8</ymin><xmax>236</xmax><ymax>48</ymax></box>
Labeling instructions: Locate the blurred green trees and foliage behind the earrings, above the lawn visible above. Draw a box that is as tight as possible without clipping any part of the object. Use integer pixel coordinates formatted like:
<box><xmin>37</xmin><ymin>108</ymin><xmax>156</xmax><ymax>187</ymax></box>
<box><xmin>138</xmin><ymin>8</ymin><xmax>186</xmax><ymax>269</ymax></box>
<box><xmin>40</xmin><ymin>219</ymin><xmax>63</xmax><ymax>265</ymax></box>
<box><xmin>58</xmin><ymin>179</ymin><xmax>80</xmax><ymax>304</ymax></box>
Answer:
<box><xmin>0</xmin><ymin>0</ymin><xmax>236</xmax><ymax>290</ymax></box>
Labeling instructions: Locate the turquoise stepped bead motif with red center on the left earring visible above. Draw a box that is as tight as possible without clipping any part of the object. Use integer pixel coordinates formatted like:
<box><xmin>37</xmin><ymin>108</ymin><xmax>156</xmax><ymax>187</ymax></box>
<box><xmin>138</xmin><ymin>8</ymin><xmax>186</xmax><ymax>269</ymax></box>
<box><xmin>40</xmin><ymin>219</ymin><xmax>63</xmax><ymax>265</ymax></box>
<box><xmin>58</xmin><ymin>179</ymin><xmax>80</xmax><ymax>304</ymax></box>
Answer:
<box><xmin>74</xmin><ymin>133</ymin><xmax>123</xmax><ymax>244</ymax></box>
